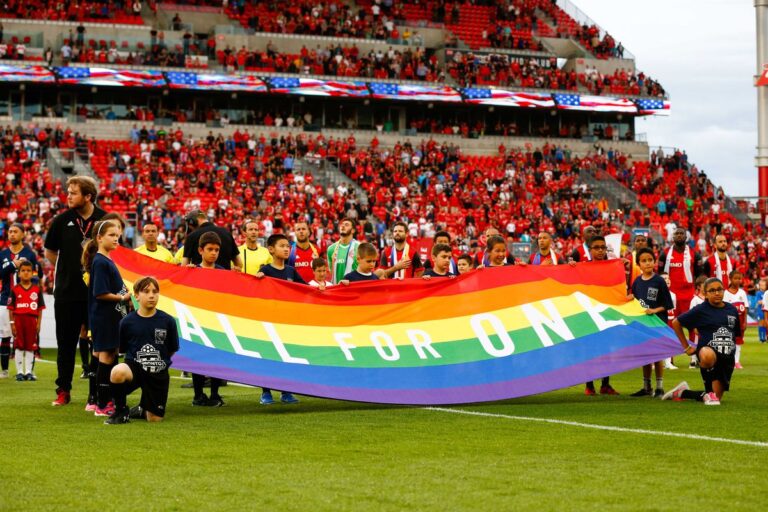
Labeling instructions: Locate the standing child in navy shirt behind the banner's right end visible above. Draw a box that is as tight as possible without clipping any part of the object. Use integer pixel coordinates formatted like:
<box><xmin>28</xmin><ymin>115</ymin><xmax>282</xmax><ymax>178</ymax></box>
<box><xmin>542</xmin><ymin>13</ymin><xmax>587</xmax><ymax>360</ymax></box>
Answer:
<box><xmin>631</xmin><ymin>247</ymin><xmax>674</xmax><ymax>398</ymax></box>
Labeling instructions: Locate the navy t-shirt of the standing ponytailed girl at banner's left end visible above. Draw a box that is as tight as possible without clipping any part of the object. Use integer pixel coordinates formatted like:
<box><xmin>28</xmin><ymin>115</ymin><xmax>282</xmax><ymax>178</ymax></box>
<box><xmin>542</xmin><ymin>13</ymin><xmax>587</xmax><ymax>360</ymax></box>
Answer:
<box><xmin>88</xmin><ymin>253</ymin><xmax>128</xmax><ymax>331</ymax></box>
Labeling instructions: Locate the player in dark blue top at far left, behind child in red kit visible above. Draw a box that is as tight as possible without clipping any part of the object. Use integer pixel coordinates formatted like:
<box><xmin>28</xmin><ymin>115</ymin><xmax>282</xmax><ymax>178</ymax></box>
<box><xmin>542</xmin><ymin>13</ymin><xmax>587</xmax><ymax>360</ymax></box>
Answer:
<box><xmin>0</xmin><ymin>223</ymin><xmax>42</xmax><ymax>379</ymax></box>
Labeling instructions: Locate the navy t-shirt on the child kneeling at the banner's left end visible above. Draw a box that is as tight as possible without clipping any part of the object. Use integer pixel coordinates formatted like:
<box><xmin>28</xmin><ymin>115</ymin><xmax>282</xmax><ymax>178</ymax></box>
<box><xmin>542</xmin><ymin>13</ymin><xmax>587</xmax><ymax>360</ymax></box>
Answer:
<box><xmin>120</xmin><ymin>309</ymin><xmax>179</xmax><ymax>373</ymax></box>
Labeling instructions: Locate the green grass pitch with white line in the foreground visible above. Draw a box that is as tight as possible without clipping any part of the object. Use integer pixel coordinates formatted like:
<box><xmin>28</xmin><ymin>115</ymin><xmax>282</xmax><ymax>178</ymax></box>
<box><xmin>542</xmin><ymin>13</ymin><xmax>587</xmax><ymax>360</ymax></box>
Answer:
<box><xmin>0</xmin><ymin>329</ymin><xmax>768</xmax><ymax>511</ymax></box>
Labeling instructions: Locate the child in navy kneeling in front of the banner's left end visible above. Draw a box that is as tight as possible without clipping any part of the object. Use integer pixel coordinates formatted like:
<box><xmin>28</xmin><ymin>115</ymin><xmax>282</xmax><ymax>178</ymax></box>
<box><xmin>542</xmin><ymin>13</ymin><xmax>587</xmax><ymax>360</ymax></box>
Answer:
<box><xmin>104</xmin><ymin>277</ymin><xmax>179</xmax><ymax>425</ymax></box>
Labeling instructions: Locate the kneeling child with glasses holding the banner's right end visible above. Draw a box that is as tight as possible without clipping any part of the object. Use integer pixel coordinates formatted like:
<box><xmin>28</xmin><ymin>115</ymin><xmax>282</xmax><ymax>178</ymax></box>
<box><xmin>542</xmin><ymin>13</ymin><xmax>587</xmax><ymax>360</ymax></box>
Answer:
<box><xmin>662</xmin><ymin>277</ymin><xmax>742</xmax><ymax>405</ymax></box>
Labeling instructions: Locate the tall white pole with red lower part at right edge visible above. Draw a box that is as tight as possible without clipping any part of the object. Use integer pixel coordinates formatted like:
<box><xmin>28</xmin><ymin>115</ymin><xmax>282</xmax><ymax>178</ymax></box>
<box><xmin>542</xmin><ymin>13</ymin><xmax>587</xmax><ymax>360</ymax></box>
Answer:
<box><xmin>755</xmin><ymin>0</ymin><xmax>768</xmax><ymax>198</ymax></box>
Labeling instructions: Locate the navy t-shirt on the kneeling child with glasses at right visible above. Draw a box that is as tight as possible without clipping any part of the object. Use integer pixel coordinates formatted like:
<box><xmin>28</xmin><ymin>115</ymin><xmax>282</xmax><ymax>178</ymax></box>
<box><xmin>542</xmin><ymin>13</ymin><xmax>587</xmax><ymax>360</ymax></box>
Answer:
<box><xmin>677</xmin><ymin>302</ymin><xmax>741</xmax><ymax>357</ymax></box>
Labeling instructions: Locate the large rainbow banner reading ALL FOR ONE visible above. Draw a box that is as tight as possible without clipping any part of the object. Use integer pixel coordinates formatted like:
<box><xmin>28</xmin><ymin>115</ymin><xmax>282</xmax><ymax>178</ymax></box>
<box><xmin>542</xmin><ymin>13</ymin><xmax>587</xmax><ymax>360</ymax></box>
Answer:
<box><xmin>113</xmin><ymin>249</ymin><xmax>680</xmax><ymax>404</ymax></box>
